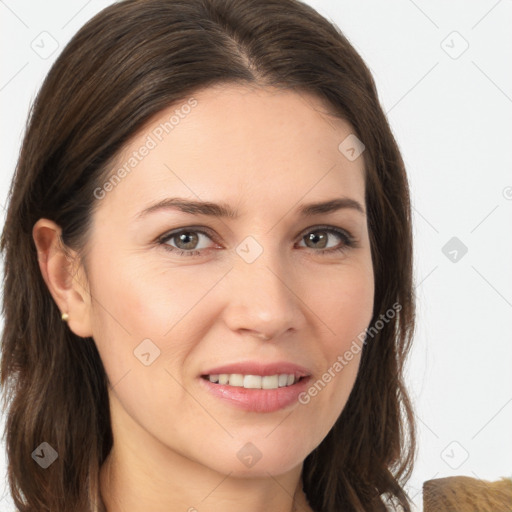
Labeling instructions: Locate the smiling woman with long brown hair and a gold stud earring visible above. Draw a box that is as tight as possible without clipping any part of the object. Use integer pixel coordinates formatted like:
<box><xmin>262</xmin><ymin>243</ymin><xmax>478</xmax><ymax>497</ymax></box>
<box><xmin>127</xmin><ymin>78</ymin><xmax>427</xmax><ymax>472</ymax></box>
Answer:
<box><xmin>1</xmin><ymin>0</ymin><xmax>414</xmax><ymax>512</ymax></box>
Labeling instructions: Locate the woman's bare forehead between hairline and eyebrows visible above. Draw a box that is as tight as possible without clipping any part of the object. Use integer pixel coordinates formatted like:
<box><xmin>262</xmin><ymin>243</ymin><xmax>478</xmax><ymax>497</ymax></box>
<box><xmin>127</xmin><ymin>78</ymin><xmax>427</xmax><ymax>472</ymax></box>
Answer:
<box><xmin>92</xmin><ymin>84</ymin><xmax>364</xmax><ymax>222</ymax></box>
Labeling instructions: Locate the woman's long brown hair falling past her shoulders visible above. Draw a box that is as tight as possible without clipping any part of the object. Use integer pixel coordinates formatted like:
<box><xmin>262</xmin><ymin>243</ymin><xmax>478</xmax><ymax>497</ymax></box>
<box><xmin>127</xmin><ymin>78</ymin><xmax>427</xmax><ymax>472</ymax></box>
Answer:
<box><xmin>1</xmin><ymin>0</ymin><xmax>415</xmax><ymax>512</ymax></box>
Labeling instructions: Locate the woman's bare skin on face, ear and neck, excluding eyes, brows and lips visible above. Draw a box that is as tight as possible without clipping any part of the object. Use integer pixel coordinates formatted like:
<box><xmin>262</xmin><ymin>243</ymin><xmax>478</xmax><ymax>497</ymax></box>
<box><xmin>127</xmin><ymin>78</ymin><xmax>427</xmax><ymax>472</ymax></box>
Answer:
<box><xmin>33</xmin><ymin>84</ymin><xmax>374</xmax><ymax>512</ymax></box>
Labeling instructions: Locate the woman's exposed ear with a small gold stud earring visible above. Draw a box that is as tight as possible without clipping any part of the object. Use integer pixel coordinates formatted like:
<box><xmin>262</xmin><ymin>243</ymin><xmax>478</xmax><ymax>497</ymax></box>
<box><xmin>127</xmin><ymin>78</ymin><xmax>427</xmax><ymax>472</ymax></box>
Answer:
<box><xmin>32</xmin><ymin>219</ymin><xmax>92</xmax><ymax>338</ymax></box>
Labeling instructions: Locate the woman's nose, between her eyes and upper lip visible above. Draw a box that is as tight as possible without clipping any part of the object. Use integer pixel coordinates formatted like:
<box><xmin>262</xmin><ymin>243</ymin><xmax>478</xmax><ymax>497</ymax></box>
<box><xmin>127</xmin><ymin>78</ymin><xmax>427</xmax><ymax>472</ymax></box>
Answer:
<box><xmin>223</xmin><ymin>248</ymin><xmax>306</xmax><ymax>341</ymax></box>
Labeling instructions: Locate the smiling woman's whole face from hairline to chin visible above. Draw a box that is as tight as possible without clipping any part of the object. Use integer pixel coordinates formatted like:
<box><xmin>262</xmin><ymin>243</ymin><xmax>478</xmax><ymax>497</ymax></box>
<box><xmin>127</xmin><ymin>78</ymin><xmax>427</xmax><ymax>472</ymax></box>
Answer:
<box><xmin>82</xmin><ymin>84</ymin><xmax>374</xmax><ymax>476</ymax></box>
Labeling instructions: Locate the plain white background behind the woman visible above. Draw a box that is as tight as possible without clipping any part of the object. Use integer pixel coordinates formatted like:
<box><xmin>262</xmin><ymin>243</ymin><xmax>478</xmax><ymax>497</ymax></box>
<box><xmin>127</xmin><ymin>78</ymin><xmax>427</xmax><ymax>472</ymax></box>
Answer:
<box><xmin>0</xmin><ymin>0</ymin><xmax>512</xmax><ymax>511</ymax></box>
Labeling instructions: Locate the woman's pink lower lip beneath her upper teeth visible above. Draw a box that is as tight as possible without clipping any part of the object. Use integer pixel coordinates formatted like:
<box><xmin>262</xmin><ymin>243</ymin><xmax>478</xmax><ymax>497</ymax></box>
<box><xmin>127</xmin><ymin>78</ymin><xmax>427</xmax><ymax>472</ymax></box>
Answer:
<box><xmin>199</xmin><ymin>377</ymin><xmax>310</xmax><ymax>412</ymax></box>
